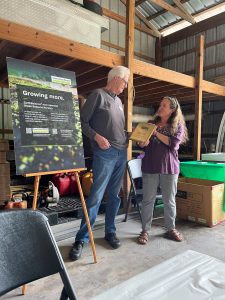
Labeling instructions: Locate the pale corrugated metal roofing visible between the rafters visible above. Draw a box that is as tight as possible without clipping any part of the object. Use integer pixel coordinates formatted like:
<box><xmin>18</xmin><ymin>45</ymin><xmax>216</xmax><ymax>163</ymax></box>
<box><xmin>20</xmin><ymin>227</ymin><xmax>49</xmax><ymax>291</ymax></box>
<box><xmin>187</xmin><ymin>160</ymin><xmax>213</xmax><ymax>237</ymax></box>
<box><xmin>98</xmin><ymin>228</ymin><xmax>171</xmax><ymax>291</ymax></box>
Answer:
<box><xmin>137</xmin><ymin>0</ymin><xmax>224</xmax><ymax>30</ymax></box>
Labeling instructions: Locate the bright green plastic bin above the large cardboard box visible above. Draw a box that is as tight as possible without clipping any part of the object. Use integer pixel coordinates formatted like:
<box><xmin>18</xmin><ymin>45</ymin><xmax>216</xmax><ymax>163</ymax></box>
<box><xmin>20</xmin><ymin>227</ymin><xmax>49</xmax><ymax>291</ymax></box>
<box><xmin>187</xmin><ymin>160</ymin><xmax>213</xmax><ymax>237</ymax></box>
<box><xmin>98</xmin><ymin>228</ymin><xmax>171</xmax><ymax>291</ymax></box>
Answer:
<box><xmin>180</xmin><ymin>161</ymin><xmax>225</xmax><ymax>211</ymax></box>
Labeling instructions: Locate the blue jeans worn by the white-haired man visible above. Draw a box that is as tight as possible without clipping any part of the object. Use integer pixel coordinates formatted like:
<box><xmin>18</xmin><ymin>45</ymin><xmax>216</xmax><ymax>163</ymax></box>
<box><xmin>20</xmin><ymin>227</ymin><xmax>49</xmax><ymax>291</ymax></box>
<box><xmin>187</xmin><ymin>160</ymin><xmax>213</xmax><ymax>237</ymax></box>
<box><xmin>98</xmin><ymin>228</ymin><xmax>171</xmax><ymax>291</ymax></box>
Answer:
<box><xmin>75</xmin><ymin>147</ymin><xmax>127</xmax><ymax>243</ymax></box>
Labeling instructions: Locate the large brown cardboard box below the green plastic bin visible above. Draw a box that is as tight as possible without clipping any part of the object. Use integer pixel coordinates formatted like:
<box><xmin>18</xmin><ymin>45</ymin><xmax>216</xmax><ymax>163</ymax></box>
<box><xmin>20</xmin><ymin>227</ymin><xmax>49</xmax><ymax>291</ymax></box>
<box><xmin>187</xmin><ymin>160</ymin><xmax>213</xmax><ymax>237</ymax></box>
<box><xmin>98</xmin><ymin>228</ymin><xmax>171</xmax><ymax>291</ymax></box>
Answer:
<box><xmin>176</xmin><ymin>177</ymin><xmax>225</xmax><ymax>227</ymax></box>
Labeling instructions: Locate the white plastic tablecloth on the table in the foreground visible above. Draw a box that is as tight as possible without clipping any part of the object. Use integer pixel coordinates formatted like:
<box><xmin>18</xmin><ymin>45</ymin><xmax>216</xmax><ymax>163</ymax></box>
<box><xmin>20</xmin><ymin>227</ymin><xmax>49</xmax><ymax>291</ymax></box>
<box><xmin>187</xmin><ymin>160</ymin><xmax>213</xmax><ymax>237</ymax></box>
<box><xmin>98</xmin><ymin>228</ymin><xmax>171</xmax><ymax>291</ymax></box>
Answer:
<box><xmin>92</xmin><ymin>250</ymin><xmax>225</xmax><ymax>300</ymax></box>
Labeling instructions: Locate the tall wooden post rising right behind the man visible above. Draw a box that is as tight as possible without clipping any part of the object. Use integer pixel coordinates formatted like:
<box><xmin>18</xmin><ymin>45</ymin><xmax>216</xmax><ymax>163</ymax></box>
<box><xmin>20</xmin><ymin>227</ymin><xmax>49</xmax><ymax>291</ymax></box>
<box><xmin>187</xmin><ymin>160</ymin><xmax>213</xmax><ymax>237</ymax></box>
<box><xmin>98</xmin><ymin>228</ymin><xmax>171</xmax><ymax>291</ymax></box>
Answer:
<box><xmin>124</xmin><ymin>0</ymin><xmax>135</xmax><ymax>207</ymax></box>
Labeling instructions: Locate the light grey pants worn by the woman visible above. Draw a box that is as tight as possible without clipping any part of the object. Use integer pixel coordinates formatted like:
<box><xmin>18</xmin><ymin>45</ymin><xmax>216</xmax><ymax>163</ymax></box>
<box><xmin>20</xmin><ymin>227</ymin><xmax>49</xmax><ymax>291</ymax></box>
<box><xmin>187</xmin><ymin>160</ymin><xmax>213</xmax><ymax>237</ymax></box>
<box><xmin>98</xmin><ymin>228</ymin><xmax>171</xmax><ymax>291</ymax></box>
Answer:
<box><xmin>141</xmin><ymin>173</ymin><xmax>178</xmax><ymax>231</ymax></box>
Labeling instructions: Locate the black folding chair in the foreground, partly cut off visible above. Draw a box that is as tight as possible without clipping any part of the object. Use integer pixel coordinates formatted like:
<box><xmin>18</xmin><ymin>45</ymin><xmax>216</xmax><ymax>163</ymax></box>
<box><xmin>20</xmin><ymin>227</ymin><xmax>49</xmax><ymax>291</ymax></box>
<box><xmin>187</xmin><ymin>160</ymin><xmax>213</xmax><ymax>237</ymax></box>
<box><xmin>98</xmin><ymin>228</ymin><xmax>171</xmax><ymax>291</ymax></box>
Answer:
<box><xmin>0</xmin><ymin>210</ymin><xmax>77</xmax><ymax>300</ymax></box>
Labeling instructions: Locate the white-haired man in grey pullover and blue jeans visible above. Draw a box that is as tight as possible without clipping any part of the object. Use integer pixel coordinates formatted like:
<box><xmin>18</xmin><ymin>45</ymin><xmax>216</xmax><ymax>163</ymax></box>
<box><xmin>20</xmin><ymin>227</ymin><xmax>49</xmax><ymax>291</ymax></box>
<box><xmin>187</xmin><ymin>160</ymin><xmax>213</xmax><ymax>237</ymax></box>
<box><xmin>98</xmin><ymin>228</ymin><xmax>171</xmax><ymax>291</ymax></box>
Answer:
<box><xmin>69</xmin><ymin>66</ymin><xmax>130</xmax><ymax>260</ymax></box>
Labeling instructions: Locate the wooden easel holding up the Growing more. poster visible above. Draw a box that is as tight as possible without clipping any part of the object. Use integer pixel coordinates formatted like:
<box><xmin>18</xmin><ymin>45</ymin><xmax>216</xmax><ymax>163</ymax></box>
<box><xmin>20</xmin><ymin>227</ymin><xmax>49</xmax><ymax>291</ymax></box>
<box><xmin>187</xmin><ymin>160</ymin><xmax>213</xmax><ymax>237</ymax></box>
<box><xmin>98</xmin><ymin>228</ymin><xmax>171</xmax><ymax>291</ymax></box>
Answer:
<box><xmin>22</xmin><ymin>168</ymin><xmax>97</xmax><ymax>295</ymax></box>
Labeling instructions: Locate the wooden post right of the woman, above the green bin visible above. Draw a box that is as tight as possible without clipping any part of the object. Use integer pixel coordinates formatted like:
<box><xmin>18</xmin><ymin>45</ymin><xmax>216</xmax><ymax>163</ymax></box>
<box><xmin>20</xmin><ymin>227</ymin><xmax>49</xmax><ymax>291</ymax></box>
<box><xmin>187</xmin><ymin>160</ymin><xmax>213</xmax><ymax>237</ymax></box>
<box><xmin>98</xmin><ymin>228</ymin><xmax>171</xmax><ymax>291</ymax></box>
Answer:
<box><xmin>194</xmin><ymin>35</ymin><xmax>204</xmax><ymax>160</ymax></box>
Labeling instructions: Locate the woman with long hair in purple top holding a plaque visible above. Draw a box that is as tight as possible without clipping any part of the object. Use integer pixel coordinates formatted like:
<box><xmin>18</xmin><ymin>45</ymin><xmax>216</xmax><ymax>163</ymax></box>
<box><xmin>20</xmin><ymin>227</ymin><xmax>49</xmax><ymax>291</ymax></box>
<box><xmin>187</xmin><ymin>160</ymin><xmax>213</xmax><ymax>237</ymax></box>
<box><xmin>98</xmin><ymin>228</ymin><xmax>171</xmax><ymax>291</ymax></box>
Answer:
<box><xmin>138</xmin><ymin>97</ymin><xmax>188</xmax><ymax>245</ymax></box>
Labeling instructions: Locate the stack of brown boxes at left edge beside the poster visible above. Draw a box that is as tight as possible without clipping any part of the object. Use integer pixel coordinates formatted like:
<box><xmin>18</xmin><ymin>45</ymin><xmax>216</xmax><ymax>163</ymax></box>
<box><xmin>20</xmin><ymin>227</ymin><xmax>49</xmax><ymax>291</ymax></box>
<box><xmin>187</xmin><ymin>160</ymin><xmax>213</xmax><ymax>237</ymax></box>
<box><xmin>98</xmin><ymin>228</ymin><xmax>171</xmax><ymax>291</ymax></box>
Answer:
<box><xmin>0</xmin><ymin>140</ymin><xmax>10</xmax><ymax>204</ymax></box>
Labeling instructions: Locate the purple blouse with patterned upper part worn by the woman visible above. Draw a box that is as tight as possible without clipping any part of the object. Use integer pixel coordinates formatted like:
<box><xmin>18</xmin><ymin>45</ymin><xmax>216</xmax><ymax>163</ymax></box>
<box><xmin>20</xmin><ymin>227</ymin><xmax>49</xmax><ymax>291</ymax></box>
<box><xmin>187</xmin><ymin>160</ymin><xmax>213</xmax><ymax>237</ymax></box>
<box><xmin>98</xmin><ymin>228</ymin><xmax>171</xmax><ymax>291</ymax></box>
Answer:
<box><xmin>142</xmin><ymin>125</ymin><xmax>184</xmax><ymax>174</ymax></box>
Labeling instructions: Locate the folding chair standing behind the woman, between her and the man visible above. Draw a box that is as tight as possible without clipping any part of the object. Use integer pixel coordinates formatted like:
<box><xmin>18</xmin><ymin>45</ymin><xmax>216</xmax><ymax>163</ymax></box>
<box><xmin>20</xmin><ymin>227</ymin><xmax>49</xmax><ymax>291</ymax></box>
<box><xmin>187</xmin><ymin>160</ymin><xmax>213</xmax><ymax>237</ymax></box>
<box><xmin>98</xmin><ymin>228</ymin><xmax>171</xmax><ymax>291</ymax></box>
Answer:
<box><xmin>124</xmin><ymin>158</ymin><xmax>162</xmax><ymax>222</ymax></box>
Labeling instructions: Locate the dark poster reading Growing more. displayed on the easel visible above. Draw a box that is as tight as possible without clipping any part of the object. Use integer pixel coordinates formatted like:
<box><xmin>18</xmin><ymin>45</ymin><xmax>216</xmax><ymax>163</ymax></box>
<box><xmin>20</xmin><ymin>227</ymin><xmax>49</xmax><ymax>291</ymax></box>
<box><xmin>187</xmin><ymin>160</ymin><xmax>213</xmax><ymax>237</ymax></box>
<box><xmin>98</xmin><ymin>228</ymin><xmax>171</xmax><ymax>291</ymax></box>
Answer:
<box><xmin>7</xmin><ymin>58</ymin><xmax>85</xmax><ymax>174</ymax></box>
